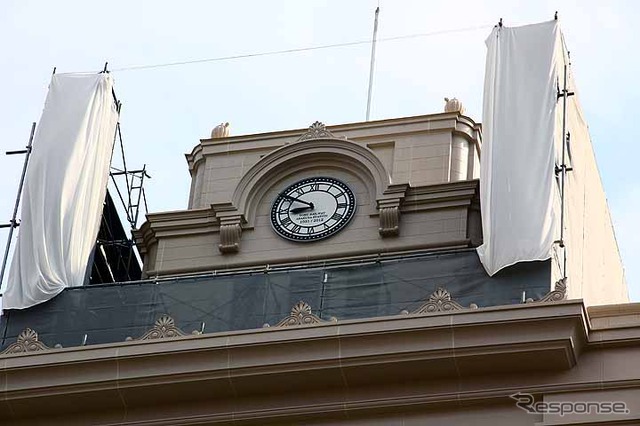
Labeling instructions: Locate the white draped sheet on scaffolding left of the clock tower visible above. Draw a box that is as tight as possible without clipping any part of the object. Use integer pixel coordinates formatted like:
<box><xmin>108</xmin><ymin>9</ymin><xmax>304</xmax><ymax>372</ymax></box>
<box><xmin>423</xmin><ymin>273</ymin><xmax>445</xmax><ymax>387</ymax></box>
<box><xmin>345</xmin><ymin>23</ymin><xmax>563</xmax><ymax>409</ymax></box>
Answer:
<box><xmin>2</xmin><ymin>73</ymin><xmax>118</xmax><ymax>309</ymax></box>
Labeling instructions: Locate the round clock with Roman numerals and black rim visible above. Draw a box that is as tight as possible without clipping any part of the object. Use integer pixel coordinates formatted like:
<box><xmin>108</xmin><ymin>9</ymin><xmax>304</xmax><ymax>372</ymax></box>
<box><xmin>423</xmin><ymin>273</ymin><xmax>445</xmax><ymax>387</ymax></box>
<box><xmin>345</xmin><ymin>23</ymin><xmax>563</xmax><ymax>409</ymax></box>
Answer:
<box><xmin>271</xmin><ymin>177</ymin><xmax>356</xmax><ymax>241</ymax></box>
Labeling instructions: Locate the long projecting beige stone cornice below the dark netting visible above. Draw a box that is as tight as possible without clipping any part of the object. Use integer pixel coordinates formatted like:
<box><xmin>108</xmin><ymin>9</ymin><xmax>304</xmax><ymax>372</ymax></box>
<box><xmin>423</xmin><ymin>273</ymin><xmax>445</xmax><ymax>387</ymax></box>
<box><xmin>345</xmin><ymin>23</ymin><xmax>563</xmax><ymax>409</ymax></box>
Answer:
<box><xmin>0</xmin><ymin>301</ymin><xmax>606</xmax><ymax>425</ymax></box>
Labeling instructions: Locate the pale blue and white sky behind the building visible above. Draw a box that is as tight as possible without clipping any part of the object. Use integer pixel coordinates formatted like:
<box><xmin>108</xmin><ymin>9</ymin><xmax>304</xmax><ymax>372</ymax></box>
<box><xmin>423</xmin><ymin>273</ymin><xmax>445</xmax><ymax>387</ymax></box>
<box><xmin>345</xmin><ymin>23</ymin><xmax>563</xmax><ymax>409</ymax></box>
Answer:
<box><xmin>0</xmin><ymin>0</ymin><xmax>640</xmax><ymax>301</ymax></box>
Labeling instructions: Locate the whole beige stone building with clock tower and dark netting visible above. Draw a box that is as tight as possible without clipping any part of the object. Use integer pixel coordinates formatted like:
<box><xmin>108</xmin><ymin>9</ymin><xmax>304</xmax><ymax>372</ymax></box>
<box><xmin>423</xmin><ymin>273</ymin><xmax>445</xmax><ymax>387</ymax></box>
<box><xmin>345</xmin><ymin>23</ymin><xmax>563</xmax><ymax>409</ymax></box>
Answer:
<box><xmin>0</xmin><ymin>111</ymin><xmax>640</xmax><ymax>425</ymax></box>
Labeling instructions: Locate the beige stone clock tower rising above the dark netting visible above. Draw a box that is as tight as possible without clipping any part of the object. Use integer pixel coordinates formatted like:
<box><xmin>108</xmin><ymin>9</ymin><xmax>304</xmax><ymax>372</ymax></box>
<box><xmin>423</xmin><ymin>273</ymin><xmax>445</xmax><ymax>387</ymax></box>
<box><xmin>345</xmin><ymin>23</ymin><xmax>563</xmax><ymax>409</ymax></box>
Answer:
<box><xmin>138</xmin><ymin>112</ymin><xmax>481</xmax><ymax>277</ymax></box>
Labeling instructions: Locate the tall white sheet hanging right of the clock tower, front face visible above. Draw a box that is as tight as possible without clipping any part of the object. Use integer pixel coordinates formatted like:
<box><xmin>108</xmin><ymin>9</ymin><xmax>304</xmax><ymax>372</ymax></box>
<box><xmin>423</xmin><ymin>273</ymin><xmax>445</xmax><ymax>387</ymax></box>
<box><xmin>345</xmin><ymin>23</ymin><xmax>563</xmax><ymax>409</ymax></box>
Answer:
<box><xmin>478</xmin><ymin>21</ymin><xmax>564</xmax><ymax>275</ymax></box>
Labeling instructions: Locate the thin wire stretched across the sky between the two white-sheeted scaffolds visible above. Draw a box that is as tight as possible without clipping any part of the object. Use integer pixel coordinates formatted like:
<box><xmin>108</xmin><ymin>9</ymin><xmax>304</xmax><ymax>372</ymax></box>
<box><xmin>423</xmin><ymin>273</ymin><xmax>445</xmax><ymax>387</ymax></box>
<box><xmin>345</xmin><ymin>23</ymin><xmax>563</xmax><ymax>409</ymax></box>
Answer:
<box><xmin>111</xmin><ymin>24</ymin><xmax>493</xmax><ymax>72</ymax></box>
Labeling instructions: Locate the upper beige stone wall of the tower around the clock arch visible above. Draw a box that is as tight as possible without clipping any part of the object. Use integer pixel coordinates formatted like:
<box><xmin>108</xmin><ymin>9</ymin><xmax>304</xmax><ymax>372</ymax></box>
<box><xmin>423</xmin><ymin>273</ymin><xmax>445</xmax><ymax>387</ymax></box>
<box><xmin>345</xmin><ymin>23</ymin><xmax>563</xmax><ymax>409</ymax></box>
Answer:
<box><xmin>187</xmin><ymin>113</ymin><xmax>480</xmax><ymax>208</ymax></box>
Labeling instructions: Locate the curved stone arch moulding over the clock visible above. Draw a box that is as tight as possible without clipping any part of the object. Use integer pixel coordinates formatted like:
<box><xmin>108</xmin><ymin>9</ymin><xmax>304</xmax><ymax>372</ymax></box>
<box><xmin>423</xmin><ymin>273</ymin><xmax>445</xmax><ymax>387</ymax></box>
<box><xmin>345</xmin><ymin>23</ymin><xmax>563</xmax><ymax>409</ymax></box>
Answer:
<box><xmin>232</xmin><ymin>138</ymin><xmax>391</xmax><ymax>228</ymax></box>
